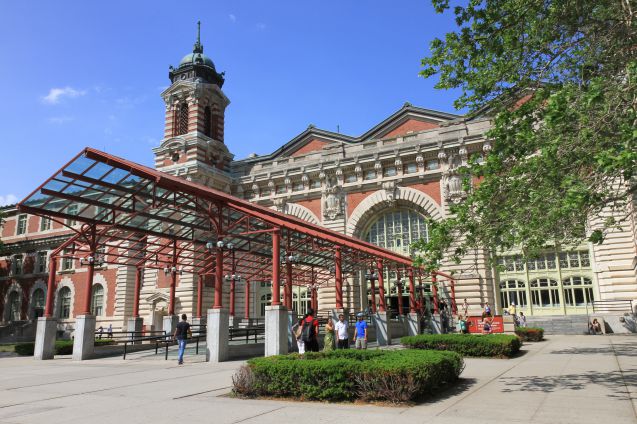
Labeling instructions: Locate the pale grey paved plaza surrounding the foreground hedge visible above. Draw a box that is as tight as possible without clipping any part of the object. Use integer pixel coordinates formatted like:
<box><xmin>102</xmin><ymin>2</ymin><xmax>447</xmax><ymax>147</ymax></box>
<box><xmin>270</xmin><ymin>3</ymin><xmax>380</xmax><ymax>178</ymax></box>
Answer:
<box><xmin>0</xmin><ymin>336</ymin><xmax>637</xmax><ymax>424</ymax></box>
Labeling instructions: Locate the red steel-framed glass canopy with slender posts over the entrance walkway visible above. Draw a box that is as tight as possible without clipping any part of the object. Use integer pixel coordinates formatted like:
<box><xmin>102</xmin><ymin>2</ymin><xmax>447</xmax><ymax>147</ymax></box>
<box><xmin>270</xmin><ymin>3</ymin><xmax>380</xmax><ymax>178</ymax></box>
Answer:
<box><xmin>18</xmin><ymin>148</ymin><xmax>452</xmax><ymax>316</ymax></box>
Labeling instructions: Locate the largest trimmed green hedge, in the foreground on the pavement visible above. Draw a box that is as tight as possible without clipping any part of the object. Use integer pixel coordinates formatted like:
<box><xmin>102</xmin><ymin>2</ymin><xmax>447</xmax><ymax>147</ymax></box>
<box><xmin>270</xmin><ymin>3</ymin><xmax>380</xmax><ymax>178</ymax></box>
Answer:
<box><xmin>232</xmin><ymin>349</ymin><xmax>464</xmax><ymax>402</ymax></box>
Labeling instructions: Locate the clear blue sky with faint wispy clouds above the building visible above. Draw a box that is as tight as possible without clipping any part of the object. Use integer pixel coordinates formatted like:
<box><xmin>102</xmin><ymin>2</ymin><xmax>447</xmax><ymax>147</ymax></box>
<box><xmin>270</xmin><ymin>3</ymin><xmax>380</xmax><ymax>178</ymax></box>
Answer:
<box><xmin>0</xmin><ymin>0</ymin><xmax>454</xmax><ymax>204</ymax></box>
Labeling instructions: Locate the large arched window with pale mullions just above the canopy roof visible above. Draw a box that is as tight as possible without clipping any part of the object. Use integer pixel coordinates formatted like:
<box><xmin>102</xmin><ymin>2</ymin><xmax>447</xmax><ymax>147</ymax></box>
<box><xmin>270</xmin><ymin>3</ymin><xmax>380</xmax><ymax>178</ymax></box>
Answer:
<box><xmin>363</xmin><ymin>209</ymin><xmax>429</xmax><ymax>255</ymax></box>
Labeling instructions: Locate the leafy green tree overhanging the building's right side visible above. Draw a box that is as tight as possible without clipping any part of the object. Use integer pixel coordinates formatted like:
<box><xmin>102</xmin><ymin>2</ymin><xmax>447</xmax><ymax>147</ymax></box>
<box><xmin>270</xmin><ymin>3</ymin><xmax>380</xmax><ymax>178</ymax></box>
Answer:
<box><xmin>414</xmin><ymin>0</ymin><xmax>637</xmax><ymax>269</ymax></box>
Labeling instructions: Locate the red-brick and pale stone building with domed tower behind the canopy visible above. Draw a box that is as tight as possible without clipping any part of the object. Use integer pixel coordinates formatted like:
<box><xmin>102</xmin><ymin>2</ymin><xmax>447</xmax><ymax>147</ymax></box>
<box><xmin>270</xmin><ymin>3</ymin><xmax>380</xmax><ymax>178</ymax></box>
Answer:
<box><xmin>0</xmin><ymin>29</ymin><xmax>637</xmax><ymax>336</ymax></box>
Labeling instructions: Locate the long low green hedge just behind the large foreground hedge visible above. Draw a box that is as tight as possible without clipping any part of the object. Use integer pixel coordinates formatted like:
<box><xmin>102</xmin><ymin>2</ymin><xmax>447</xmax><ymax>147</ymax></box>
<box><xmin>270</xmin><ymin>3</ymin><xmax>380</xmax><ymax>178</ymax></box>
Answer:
<box><xmin>400</xmin><ymin>334</ymin><xmax>522</xmax><ymax>358</ymax></box>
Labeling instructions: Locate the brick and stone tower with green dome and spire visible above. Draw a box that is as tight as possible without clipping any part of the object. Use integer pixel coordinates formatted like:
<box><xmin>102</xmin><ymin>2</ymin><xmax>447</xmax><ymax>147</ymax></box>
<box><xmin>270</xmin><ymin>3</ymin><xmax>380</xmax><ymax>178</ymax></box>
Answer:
<box><xmin>153</xmin><ymin>22</ymin><xmax>233</xmax><ymax>192</ymax></box>
